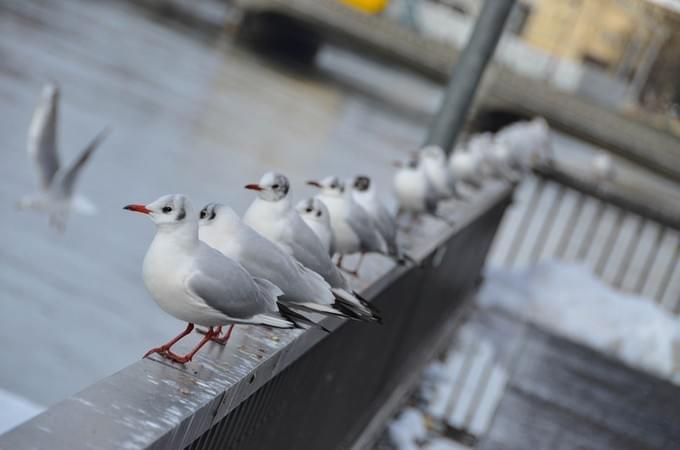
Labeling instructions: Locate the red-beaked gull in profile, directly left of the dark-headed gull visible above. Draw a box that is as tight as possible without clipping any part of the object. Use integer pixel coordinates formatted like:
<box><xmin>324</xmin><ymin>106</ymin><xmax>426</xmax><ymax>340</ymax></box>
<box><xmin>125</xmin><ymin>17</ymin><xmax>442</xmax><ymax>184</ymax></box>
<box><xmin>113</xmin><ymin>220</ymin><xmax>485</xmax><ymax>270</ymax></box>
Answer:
<box><xmin>307</xmin><ymin>176</ymin><xmax>387</xmax><ymax>276</ymax></box>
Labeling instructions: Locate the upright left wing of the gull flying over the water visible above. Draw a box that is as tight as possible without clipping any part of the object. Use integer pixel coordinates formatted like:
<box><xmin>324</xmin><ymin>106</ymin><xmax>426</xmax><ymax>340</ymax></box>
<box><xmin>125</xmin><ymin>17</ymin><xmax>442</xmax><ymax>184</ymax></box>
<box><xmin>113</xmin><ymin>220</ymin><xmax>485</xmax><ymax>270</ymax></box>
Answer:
<box><xmin>27</xmin><ymin>87</ymin><xmax>59</xmax><ymax>190</ymax></box>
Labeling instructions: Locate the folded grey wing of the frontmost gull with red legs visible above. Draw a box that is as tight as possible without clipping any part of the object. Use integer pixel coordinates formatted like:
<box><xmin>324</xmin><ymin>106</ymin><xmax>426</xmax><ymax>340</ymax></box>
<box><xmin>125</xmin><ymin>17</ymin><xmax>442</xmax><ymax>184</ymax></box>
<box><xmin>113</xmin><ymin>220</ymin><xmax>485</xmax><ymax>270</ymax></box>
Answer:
<box><xmin>186</xmin><ymin>244</ymin><xmax>280</xmax><ymax>319</ymax></box>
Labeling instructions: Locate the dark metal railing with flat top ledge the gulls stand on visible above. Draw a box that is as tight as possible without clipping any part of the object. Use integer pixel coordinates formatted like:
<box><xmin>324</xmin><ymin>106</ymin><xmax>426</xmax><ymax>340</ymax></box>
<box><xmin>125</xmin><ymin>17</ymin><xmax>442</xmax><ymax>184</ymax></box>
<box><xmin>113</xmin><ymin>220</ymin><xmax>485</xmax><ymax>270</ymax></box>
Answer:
<box><xmin>0</xmin><ymin>183</ymin><xmax>511</xmax><ymax>450</ymax></box>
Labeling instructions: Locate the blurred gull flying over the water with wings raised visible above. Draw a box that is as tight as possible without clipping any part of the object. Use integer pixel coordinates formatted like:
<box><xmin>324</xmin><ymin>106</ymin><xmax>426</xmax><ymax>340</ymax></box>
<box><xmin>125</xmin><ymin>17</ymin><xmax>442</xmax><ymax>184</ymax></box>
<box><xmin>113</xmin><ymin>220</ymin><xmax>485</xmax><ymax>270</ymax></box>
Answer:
<box><xmin>17</xmin><ymin>83</ymin><xmax>109</xmax><ymax>230</ymax></box>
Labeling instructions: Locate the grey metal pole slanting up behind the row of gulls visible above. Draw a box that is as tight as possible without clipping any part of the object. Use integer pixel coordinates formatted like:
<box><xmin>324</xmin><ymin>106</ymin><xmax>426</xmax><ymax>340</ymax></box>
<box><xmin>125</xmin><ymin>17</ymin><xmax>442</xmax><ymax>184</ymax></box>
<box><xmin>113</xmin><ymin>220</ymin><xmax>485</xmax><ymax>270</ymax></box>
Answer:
<box><xmin>425</xmin><ymin>0</ymin><xmax>515</xmax><ymax>153</ymax></box>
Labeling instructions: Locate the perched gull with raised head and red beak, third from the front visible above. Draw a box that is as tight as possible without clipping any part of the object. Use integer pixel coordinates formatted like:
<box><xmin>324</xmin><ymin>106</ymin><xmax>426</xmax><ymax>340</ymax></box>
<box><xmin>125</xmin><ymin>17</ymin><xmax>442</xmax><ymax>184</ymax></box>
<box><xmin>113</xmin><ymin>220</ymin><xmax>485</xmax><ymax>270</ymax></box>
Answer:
<box><xmin>243</xmin><ymin>172</ymin><xmax>380</xmax><ymax>322</ymax></box>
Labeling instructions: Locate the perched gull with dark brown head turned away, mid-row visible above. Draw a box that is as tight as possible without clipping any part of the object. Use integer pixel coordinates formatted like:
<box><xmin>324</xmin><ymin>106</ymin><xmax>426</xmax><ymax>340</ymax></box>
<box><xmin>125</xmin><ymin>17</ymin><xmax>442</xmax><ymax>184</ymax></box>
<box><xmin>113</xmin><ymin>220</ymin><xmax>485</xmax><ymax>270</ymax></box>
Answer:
<box><xmin>352</xmin><ymin>175</ymin><xmax>415</xmax><ymax>262</ymax></box>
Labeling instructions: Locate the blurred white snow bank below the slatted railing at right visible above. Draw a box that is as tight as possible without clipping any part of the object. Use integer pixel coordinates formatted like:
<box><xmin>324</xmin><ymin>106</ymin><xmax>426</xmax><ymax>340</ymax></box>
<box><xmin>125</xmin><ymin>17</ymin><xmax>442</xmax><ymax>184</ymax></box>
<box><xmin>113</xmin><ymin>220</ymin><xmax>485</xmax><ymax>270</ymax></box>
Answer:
<box><xmin>478</xmin><ymin>262</ymin><xmax>680</xmax><ymax>384</ymax></box>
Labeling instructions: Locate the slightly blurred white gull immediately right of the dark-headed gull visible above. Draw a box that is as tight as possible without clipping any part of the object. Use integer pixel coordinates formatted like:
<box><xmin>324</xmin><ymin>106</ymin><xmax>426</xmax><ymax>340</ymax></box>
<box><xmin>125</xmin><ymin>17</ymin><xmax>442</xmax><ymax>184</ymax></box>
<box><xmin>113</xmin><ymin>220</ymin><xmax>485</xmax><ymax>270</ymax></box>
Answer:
<box><xmin>393</xmin><ymin>157</ymin><xmax>451</xmax><ymax>229</ymax></box>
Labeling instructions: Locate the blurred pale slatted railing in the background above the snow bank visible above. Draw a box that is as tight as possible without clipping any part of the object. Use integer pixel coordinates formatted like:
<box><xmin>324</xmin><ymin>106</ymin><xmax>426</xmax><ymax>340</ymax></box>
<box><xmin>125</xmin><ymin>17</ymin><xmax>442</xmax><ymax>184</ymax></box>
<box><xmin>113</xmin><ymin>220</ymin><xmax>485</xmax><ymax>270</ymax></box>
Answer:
<box><xmin>490</xmin><ymin>163</ymin><xmax>680</xmax><ymax>314</ymax></box>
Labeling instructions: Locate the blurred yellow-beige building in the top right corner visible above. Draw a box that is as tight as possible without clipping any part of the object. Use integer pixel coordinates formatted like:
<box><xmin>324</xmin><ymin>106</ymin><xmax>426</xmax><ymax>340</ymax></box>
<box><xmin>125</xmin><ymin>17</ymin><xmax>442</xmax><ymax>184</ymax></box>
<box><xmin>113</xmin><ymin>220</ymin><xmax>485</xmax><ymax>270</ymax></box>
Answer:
<box><xmin>522</xmin><ymin>0</ymin><xmax>680</xmax><ymax>109</ymax></box>
